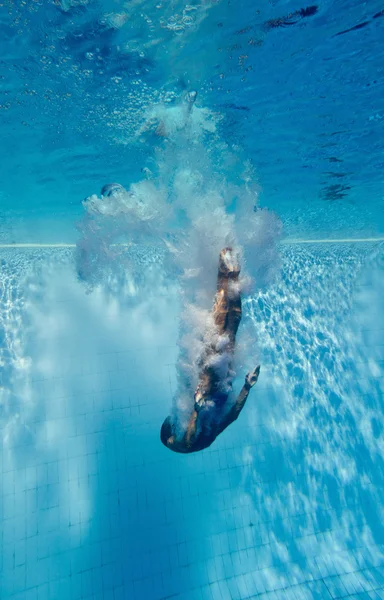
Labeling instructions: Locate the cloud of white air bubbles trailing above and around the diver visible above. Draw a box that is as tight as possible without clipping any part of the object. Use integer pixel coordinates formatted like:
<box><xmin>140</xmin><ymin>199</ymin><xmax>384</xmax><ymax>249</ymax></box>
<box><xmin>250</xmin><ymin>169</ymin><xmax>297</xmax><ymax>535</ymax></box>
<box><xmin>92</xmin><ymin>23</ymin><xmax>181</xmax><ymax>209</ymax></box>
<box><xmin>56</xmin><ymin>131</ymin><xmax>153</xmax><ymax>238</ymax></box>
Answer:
<box><xmin>77</xmin><ymin>96</ymin><xmax>281</xmax><ymax>421</ymax></box>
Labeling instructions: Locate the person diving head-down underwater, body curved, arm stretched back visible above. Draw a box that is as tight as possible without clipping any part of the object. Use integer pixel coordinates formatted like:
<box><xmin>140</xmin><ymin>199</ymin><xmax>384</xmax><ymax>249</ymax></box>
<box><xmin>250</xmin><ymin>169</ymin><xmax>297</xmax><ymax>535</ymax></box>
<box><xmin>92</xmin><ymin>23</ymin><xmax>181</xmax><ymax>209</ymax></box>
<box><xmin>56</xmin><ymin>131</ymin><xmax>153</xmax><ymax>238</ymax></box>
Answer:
<box><xmin>160</xmin><ymin>248</ymin><xmax>260</xmax><ymax>453</ymax></box>
